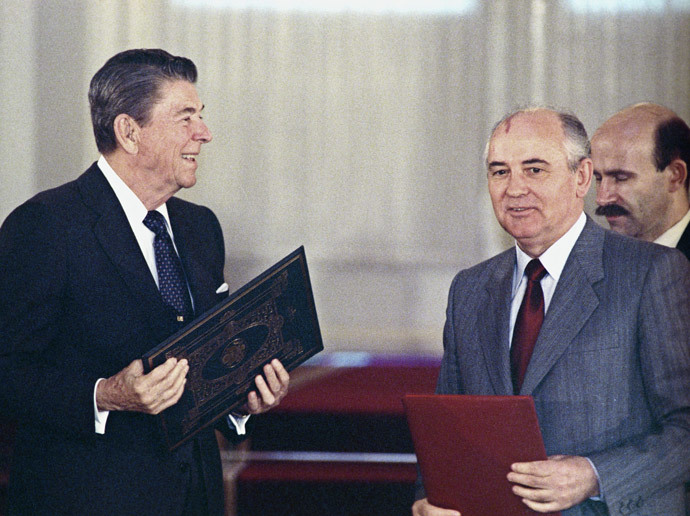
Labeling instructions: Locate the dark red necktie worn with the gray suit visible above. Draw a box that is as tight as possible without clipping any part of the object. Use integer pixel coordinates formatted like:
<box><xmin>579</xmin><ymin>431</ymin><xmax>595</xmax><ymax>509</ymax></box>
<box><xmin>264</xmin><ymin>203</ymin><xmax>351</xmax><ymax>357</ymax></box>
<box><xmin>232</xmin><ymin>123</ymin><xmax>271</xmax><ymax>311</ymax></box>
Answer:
<box><xmin>510</xmin><ymin>259</ymin><xmax>546</xmax><ymax>394</ymax></box>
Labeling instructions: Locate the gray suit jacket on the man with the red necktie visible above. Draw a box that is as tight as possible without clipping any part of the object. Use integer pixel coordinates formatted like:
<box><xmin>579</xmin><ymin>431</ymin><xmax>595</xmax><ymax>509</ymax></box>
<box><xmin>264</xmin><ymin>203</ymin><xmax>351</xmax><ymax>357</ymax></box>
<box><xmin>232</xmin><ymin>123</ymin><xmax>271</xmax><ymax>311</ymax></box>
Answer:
<box><xmin>430</xmin><ymin>218</ymin><xmax>690</xmax><ymax>516</ymax></box>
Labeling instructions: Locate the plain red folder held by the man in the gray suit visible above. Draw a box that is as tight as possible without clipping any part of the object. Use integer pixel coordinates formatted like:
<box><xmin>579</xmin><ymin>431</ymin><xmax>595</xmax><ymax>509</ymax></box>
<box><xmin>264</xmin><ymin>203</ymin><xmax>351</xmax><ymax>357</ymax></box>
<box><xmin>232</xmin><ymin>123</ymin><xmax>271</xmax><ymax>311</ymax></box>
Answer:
<box><xmin>403</xmin><ymin>394</ymin><xmax>560</xmax><ymax>516</ymax></box>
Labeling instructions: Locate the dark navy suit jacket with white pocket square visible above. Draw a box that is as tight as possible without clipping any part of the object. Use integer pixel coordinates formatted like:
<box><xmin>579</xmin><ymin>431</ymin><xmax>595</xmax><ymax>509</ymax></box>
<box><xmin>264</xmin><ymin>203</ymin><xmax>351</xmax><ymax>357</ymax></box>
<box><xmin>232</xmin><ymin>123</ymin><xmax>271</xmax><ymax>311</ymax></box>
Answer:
<box><xmin>0</xmin><ymin>164</ymin><xmax>234</xmax><ymax>515</ymax></box>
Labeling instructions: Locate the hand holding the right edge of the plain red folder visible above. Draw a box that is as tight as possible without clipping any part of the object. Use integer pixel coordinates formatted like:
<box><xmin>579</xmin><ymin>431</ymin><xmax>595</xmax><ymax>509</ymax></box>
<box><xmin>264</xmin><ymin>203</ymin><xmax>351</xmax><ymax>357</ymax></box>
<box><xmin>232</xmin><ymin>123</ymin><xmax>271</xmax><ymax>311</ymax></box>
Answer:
<box><xmin>508</xmin><ymin>455</ymin><xmax>599</xmax><ymax>512</ymax></box>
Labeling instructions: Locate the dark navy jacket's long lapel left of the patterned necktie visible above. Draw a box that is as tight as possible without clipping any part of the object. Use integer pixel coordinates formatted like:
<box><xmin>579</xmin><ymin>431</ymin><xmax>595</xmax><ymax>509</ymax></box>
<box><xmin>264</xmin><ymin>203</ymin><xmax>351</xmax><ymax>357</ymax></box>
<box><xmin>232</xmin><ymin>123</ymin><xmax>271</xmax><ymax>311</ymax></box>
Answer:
<box><xmin>77</xmin><ymin>164</ymin><xmax>167</xmax><ymax>336</ymax></box>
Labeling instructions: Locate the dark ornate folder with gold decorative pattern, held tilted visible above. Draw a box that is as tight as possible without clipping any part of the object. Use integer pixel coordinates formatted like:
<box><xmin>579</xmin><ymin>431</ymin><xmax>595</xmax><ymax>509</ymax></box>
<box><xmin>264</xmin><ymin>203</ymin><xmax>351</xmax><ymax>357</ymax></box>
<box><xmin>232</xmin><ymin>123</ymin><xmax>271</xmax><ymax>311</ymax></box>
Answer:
<box><xmin>143</xmin><ymin>247</ymin><xmax>323</xmax><ymax>449</ymax></box>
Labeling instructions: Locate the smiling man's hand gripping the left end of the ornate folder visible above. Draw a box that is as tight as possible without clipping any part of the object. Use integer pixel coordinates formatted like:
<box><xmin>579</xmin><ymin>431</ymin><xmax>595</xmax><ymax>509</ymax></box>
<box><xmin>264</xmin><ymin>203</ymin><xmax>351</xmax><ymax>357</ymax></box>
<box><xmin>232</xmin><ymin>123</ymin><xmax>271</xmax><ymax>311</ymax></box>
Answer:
<box><xmin>96</xmin><ymin>358</ymin><xmax>189</xmax><ymax>414</ymax></box>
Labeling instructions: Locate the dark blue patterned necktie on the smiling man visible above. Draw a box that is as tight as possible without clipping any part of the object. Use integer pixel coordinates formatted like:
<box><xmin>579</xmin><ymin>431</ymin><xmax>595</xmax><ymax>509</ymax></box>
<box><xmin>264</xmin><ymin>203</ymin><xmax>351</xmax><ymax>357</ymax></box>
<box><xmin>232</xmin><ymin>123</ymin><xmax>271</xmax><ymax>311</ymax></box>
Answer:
<box><xmin>144</xmin><ymin>211</ymin><xmax>193</xmax><ymax>322</ymax></box>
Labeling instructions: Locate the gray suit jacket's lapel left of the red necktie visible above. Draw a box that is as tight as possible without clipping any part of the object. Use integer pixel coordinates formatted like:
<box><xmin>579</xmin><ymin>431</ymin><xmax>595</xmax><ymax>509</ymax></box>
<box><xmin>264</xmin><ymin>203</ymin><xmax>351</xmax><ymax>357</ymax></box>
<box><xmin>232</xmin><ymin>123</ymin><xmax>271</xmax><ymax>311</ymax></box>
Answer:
<box><xmin>477</xmin><ymin>248</ymin><xmax>515</xmax><ymax>395</ymax></box>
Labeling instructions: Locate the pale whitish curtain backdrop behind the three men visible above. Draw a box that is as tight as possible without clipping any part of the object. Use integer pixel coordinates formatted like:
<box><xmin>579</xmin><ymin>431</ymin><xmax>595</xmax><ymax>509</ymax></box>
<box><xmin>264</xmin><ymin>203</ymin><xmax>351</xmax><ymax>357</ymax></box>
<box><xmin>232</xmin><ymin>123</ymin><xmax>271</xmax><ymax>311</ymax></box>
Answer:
<box><xmin>0</xmin><ymin>0</ymin><xmax>690</xmax><ymax>354</ymax></box>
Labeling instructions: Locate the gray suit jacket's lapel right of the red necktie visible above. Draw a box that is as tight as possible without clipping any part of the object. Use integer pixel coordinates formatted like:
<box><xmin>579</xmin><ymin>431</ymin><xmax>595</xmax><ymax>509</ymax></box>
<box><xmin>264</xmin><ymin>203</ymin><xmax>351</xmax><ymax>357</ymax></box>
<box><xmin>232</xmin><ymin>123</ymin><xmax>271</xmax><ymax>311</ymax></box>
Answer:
<box><xmin>520</xmin><ymin>217</ymin><xmax>604</xmax><ymax>394</ymax></box>
